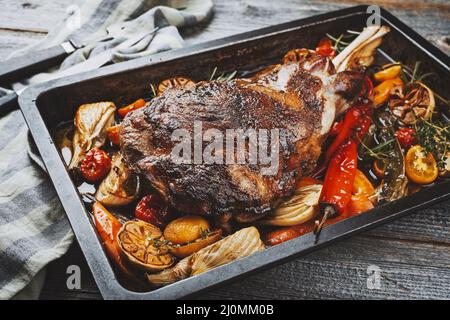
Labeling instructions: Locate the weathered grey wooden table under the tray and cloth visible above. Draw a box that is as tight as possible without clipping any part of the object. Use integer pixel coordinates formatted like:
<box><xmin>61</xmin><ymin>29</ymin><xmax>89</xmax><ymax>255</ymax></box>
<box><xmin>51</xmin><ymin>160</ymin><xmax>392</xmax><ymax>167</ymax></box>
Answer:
<box><xmin>0</xmin><ymin>0</ymin><xmax>450</xmax><ymax>299</ymax></box>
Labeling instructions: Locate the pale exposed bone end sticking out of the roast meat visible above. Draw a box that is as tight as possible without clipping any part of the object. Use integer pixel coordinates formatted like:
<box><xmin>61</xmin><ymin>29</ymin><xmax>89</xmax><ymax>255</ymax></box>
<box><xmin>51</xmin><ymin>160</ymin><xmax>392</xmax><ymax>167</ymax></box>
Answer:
<box><xmin>333</xmin><ymin>26</ymin><xmax>390</xmax><ymax>72</ymax></box>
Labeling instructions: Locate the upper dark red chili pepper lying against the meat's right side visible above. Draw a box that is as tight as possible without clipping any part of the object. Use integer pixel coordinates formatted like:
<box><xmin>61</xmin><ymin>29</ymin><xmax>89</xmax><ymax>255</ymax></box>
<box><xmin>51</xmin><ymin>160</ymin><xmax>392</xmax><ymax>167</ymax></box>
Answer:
<box><xmin>325</xmin><ymin>104</ymin><xmax>372</xmax><ymax>164</ymax></box>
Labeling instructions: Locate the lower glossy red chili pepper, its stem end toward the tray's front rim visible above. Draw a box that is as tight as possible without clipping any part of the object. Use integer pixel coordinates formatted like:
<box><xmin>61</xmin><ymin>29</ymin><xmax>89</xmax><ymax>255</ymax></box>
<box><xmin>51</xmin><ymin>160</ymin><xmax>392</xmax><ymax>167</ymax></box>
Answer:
<box><xmin>320</xmin><ymin>139</ymin><xmax>358</xmax><ymax>214</ymax></box>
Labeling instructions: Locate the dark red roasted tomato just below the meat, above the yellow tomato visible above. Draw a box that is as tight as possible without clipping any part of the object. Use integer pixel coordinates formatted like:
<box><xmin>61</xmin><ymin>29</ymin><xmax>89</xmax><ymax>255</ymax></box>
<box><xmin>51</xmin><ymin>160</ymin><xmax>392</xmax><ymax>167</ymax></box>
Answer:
<box><xmin>135</xmin><ymin>194</ymin><xmax>171</xmax><ymax>228</ymax></box>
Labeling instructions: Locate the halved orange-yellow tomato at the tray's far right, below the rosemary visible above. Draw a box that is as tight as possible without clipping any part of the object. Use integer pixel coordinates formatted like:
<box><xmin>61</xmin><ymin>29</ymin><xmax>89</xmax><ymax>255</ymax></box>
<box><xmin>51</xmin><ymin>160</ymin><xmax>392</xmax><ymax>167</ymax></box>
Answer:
<box><xmin>405</xmin><ymin>145</ymin><xmax>439</xmax><ymax>184</ymax></box>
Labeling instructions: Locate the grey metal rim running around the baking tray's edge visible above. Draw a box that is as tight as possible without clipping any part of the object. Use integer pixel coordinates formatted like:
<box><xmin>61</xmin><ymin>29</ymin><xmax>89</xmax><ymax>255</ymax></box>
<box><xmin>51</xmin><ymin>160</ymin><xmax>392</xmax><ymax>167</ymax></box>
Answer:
<box><xmin>19</xmin><ymin>6</ymin><xmax>450</xmax><ymax>299</ymax></box>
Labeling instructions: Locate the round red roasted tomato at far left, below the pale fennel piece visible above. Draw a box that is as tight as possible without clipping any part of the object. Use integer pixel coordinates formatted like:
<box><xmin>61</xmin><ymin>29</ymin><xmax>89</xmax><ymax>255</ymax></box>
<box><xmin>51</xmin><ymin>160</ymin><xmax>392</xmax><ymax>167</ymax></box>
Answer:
<box><xmin>80</xmin><ymin>148</ymin><xmax>111</xmax><ymax>183</ymax></box>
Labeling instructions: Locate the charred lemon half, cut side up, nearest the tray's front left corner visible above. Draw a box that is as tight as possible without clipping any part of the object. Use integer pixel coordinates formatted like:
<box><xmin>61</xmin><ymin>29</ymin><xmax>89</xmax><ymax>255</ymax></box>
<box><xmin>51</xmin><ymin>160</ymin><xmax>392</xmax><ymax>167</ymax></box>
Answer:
<box><xmin>117</xmin><ymin>221</ymin><xmax>175</xmax><ymax>272</ymax></box>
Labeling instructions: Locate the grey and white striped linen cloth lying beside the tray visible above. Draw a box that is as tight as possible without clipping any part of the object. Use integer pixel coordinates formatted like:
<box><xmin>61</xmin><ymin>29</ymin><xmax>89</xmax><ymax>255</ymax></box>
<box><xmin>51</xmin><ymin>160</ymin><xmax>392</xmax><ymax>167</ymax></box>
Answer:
<box><xmin>0</xmin><ymin>0</ymin><xmax>213</xmax><ymax>299</ymax></box>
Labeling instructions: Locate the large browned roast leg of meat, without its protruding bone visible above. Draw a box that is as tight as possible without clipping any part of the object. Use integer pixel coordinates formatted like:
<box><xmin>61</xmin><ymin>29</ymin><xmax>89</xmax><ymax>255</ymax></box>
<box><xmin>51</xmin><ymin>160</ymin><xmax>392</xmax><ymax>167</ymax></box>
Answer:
<box><xmin>120</xmin><ymin>57</ymin><xmax>362</xmax><ymax>217</ymax></box>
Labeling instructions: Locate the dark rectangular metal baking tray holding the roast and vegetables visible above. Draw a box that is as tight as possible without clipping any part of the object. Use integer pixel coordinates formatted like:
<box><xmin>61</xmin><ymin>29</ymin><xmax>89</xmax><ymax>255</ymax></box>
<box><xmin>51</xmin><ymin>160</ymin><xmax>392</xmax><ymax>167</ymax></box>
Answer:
<box><xmin>19</xmin><ymin>6</ymin><xmax>450</xmax><ymax>299</ymax></box>
